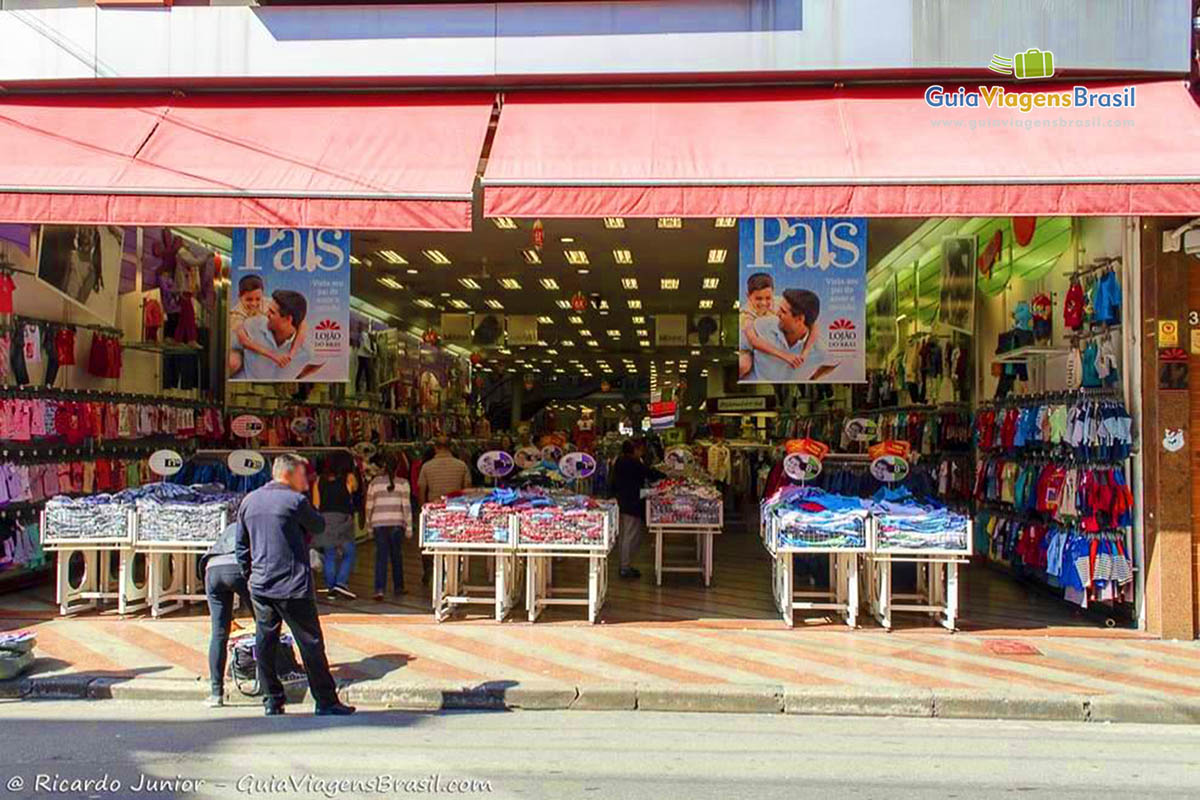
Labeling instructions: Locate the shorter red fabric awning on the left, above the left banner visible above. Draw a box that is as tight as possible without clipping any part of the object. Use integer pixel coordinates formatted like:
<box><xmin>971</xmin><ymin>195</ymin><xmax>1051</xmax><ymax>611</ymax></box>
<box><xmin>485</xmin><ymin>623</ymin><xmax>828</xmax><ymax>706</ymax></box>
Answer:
<box><xmin>0</xmin><ymin>94</ymin><xmax>493</xmax><ymax>230</ymax></box>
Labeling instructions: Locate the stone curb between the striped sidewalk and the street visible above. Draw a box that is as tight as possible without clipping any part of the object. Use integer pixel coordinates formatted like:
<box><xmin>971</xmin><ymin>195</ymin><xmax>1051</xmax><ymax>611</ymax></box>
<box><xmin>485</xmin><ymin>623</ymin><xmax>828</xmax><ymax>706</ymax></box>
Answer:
<box><xmin>0</xmin><ymin>675</ymin><xmax>1200</xmax><ymax>724</ymax></box>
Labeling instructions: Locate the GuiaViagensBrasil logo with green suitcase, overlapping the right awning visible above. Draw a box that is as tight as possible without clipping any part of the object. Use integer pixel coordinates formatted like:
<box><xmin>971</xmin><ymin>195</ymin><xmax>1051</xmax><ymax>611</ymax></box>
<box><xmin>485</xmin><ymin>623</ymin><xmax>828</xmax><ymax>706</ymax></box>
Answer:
<box><xmin>925</xmin><ymin>47</ymin><xmax>1136</xmax><ymax>114</ymax></box>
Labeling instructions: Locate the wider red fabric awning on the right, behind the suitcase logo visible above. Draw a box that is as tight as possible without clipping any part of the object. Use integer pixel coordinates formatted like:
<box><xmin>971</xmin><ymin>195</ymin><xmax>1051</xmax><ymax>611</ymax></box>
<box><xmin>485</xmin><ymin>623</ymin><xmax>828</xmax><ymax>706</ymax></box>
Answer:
<box><xmin>484</xmin><ymin>82</ymin><xmax>1200</xmax><ymax>217</ymax></box>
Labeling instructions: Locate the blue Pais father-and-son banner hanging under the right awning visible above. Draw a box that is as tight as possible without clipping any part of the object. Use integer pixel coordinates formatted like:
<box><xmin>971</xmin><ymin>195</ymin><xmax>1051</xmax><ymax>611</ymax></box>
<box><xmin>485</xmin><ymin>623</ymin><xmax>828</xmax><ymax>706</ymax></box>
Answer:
<box><xmin>738</xmin><ymin>217</ymin><xmax>866</xmax><ymax>384</ymax></box>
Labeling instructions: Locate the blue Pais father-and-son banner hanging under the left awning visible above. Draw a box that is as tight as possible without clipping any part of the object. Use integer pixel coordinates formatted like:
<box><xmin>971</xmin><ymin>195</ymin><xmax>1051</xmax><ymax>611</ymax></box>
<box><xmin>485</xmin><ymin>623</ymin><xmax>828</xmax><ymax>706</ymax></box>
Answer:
<box><xmin>228</xmin><ymin>228</ymin><xmax>350</xmax><ymax>383</ymax></box>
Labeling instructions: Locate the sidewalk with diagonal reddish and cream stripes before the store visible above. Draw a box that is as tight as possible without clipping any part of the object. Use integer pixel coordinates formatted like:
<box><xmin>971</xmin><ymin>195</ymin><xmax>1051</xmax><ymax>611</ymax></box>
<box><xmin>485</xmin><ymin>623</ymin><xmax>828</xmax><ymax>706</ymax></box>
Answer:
<box><xmin>0</xmin><ymin>527</ymin><xmax>1200</xmax><ymax>698</ymax></box>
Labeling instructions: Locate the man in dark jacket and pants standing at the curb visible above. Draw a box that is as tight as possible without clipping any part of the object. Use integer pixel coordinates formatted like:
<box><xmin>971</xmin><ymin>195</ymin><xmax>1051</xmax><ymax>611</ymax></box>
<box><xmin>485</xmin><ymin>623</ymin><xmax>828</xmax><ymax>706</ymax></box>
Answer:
<box><xmin>236</xmin><ymin>453</ymin><xmax>354</xmax><ymax>716</ymax></box>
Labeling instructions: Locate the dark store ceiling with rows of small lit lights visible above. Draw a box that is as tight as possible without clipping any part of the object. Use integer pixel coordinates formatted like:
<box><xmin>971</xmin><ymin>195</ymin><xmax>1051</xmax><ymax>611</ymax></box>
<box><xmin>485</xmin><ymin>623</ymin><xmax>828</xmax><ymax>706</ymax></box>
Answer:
<box><xmin>352</xmin><ymin>218</ymin><xmax>922</xmax><ymax>374</ymax></box>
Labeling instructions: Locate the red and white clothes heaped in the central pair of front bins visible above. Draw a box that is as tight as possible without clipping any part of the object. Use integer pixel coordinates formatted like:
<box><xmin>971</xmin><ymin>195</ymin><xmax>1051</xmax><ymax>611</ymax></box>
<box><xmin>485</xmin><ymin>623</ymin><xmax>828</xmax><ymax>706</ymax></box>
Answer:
<box><xmin>421</xmin><ymin>488</ymin><xmax>617</xmax><ymax>551</ymax></box>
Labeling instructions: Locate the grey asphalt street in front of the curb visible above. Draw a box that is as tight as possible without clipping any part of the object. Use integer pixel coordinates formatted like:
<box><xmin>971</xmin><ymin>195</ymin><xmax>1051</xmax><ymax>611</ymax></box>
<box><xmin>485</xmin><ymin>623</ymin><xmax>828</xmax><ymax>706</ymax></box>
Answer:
<box><xmin>0</xmin><ymin>700</ymin><xmax>1200</xmax><ymax>800</ymax></box>
